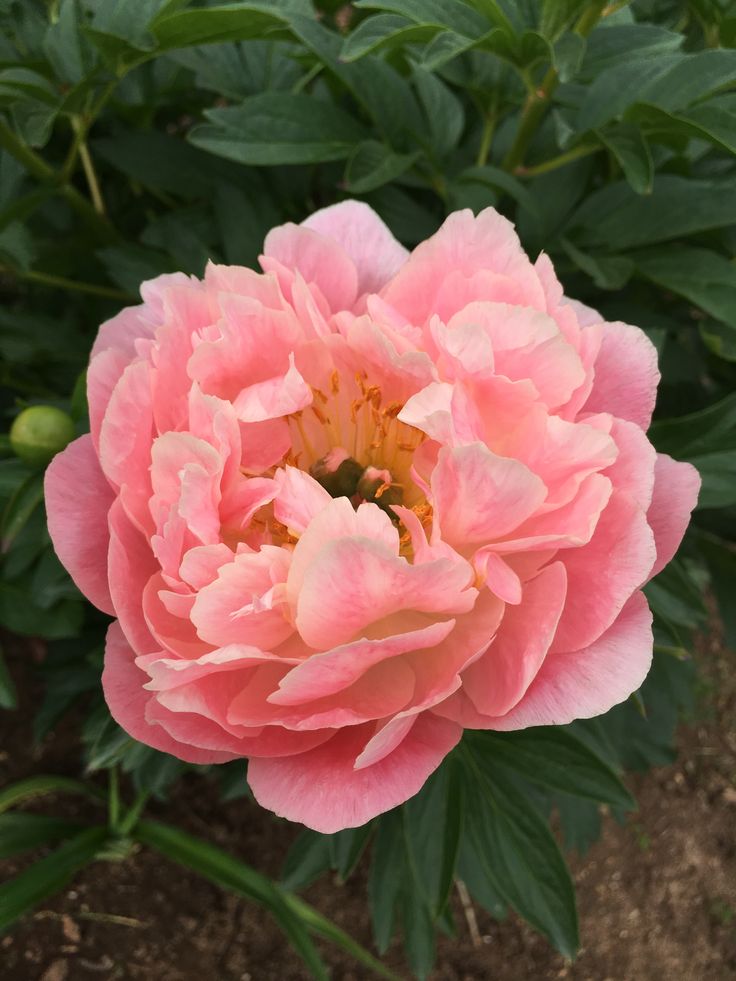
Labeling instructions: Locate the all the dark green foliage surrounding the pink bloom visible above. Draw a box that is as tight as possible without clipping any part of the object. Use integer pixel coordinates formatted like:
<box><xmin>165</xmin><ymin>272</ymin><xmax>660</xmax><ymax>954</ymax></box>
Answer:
<box><xmin>0</xmin><ymin>0</ymin><xmax>736</xmax><ymax>977</ymax></box>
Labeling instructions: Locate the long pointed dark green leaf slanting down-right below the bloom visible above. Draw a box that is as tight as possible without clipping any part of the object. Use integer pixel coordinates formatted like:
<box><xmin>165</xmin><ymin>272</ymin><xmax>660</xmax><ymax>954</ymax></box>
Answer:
<box><xmin>464</xmin><ymin>743</ymin><xmax>579</xmax><ymax>958</ymax></box>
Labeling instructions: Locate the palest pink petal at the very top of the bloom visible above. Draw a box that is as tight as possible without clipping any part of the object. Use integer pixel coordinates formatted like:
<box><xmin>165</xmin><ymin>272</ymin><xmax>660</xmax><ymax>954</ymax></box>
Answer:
<box><xmin>302</xmin><ymin>201</ymin><xmax>409</xmax><ymax>295</ymax></box>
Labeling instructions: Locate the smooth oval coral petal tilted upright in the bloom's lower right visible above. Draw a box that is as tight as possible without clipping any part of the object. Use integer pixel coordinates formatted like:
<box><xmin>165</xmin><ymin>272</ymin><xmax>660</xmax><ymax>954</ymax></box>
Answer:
<box><xmin>463</xmin><ymin>562</ymin><xmax>567</xmax><ymax>716</ymax></box>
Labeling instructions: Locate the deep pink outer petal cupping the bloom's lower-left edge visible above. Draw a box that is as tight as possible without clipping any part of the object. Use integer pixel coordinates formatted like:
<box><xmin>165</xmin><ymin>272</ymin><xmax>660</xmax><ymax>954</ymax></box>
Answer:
<box><xmin>102</xmin><ymin>623</ymin><xmax>238</xmax><ymax>763</ymax></box>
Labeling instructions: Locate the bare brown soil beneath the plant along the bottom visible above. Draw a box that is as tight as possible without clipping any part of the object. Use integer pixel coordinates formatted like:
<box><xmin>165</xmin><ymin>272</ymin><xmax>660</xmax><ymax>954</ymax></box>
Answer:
<box><xmin>0</xmin><ymin>638</ymin><xmax>736</xmax><ymax>981</ymax></box>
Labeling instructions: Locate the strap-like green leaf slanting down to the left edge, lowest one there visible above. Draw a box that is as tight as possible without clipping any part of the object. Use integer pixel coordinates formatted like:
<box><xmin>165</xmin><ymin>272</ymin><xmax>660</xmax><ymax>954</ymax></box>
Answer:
<box><xmin>0</xmin><ymin>827</ymin><xmax>108</xmax><ymax>931</ymax></box>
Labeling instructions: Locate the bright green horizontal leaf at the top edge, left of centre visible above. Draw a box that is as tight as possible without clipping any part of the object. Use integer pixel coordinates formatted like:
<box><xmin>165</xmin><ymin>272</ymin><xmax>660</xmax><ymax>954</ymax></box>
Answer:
<box><xmin>150</xmin><ymin>0</ymin><xmax>294</xmax><ymax>51</ymax></box>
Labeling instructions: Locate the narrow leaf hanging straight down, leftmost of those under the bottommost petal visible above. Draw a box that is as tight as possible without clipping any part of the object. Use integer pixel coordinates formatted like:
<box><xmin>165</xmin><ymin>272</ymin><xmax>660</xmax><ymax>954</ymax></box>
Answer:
<box><xmin>368</xmin><ymin>810</ymin><xmax>409</xmax><ymax>954</ymax></box>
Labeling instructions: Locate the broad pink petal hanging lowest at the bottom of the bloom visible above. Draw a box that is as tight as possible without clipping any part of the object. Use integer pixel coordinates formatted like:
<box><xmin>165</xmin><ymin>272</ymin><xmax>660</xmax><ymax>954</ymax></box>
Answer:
<box><xmin>248</xmin><ymin>713</ymin><xmax>462</xmax><ymax>834</ymax></box>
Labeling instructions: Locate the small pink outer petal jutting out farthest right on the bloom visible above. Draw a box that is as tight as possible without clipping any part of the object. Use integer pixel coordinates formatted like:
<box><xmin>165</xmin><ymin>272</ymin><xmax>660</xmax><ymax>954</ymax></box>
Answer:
<box><xmin>647</xmin><ymin>453</ymin><xmax>701</xmax><ymax>576</ymax></box>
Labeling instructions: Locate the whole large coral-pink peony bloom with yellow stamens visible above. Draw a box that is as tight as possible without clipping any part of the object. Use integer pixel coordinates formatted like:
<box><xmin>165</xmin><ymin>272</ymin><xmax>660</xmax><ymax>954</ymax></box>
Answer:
<box><xmin>46</xmin><ymin>201</ymin><xmax>699</xmax><ymax>832</ymax></box>
